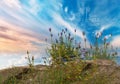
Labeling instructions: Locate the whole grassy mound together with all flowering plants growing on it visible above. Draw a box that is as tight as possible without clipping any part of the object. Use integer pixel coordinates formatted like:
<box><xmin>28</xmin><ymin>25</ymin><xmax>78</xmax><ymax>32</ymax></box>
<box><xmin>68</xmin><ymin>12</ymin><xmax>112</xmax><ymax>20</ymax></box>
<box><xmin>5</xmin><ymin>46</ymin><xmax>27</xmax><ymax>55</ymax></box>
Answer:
<box><xmin>1</xmin><ymin>28</ymin><xmax>120</xmax><ymax>84</ymax></box>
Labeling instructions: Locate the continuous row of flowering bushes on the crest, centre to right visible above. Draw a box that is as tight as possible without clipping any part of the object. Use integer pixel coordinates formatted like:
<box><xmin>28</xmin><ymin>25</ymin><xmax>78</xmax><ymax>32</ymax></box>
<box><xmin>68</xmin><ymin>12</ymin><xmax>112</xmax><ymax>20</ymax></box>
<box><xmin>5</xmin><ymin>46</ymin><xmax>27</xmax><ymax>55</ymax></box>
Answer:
<box><xmin>48</xmin><ymin>28</ymin><xmax>117</xmax><ymax>64</ymax></box>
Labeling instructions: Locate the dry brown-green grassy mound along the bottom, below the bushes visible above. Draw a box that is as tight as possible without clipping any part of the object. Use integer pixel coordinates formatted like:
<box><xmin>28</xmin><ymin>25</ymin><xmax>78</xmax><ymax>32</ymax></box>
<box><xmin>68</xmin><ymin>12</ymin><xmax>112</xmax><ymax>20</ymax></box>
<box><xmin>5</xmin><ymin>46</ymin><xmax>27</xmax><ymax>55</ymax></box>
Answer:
<box><xmin>0</xmin><ymin>60</ymin><xmax>120</xmax><ymax>84</ymax></box>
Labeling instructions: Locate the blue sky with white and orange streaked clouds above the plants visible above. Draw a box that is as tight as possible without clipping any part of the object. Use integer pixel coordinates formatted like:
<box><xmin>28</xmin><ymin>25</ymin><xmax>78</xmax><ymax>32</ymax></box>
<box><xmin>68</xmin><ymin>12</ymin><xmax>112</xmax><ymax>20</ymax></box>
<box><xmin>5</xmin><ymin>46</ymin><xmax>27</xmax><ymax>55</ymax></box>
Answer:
<box><xmin>0</xmin><ymin>0</ymin><xmax>120</xmax><ymax>68</ymax></box>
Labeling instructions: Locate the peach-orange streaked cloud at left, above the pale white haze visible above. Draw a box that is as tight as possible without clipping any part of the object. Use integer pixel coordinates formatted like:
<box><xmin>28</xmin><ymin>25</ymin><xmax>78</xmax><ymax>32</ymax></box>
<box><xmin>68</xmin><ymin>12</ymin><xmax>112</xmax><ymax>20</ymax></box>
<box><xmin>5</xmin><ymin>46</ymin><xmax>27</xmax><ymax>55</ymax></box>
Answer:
<box><xmin>0</xmin><ymin>20</ymin><xmax>45</xmax><ymax>52</ymax></box>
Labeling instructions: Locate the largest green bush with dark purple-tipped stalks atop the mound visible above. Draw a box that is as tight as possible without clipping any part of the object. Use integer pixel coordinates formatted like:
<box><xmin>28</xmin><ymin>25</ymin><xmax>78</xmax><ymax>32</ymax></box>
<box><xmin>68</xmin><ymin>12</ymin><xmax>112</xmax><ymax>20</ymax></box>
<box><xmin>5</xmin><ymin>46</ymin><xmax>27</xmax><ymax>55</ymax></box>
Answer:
<box><xmin>48</xmin><ymin>29</ymin><xmax>81</xmax><ymax>64</ymax></box>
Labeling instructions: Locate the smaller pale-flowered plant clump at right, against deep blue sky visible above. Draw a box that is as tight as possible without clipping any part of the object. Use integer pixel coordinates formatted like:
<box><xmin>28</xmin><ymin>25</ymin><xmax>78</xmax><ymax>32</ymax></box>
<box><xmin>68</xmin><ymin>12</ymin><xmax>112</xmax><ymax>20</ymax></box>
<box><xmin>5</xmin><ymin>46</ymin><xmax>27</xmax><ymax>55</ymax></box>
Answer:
<box><xmin>90</xmin><ymin>33</ymin><xmax>117</xmax><ymax>60</ymax></box>
